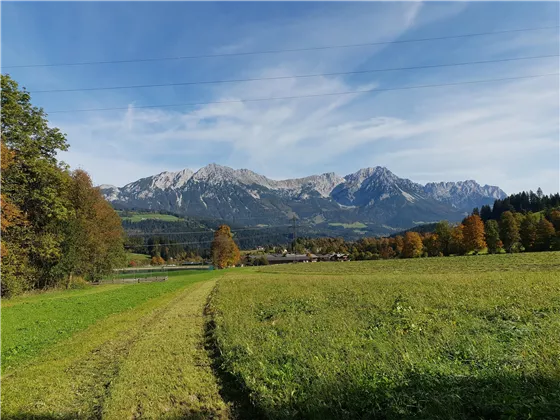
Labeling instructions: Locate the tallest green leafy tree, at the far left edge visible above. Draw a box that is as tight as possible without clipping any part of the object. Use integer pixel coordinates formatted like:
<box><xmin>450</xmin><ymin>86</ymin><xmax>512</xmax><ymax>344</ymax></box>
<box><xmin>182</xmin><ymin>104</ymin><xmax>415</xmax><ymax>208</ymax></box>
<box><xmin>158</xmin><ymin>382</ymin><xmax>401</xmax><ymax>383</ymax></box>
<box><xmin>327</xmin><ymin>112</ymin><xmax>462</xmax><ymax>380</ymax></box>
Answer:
<box><xmin>0</xmin><ymin>75</ymin><xmax>68</xmax><ymax>287</ymax></box>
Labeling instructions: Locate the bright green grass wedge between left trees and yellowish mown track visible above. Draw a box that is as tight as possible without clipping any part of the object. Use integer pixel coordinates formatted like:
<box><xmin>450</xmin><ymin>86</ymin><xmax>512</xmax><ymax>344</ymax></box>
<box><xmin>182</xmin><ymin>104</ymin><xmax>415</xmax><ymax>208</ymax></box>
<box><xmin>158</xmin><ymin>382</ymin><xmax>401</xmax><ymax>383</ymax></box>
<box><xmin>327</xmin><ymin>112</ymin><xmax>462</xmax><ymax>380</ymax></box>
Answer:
<box><xmin>0</xmin><ymin>273</ymin><xmax>208</xmax><ymax>374</ymax></box>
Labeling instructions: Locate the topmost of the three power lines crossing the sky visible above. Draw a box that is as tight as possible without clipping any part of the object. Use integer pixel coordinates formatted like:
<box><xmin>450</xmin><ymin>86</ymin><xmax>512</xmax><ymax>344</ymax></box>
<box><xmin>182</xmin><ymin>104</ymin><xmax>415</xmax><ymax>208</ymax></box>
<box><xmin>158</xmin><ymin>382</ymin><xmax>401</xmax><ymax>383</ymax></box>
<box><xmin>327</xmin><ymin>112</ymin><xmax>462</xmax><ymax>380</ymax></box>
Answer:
<box><xmin>4</xmin><ymin>25</ymin><xmax>560</xmax><ymax>69</ymax></box>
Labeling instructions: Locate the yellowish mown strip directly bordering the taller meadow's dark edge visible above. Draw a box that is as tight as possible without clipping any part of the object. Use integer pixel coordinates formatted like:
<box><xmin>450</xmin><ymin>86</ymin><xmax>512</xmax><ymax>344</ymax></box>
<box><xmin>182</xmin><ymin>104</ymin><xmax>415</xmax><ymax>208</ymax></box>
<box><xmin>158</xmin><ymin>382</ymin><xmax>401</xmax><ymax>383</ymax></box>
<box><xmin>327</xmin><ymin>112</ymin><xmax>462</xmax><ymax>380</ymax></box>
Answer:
<box><xmin>103</xmin><ymin>282</ymin><xmax>229</xmax><ymax>420</ymax></box>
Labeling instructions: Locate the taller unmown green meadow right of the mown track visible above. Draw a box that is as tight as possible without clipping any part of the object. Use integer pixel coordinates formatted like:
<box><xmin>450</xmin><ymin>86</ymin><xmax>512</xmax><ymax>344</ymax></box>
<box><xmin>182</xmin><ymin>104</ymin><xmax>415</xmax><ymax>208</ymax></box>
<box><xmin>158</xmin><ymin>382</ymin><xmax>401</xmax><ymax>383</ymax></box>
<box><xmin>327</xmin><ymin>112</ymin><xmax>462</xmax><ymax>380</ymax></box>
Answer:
<box><xmin>213</xmin><ymin>253</ymin><xmax>560</xmax><ymax>419</ymax></box>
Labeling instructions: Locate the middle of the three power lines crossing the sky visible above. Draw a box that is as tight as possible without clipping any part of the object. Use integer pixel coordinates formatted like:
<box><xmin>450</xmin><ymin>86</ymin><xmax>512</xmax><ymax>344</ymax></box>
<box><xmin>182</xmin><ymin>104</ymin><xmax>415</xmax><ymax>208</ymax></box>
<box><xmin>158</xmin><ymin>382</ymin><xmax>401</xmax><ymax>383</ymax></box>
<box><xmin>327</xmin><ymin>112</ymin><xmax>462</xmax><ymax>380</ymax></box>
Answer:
<box><xmin>29</xmin><ymin>54</ymin><xmax>560</xmax><ymax>94</ymax></box>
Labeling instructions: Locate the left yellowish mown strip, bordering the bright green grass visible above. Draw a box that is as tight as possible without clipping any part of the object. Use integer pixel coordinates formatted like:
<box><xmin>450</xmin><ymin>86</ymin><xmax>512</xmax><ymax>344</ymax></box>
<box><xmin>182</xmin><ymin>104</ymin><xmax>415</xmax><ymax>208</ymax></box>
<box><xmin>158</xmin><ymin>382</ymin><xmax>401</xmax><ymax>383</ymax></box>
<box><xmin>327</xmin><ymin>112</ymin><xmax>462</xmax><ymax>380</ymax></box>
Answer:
<box><xmin>0</xmin><ymin>273</ymin><xmax>217</xmax><ymax>419</ymax></box>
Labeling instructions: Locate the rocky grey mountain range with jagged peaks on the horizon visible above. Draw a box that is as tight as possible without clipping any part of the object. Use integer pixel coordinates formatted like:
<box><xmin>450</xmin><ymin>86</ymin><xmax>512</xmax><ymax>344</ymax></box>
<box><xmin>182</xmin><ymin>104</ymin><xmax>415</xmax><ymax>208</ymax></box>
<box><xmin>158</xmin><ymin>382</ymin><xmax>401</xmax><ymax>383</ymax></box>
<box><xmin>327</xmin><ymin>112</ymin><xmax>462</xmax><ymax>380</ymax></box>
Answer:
<box><xmin>100</xmin><ymin>164</ymin><xmax>506</xmax><ymax>234</ymax></box>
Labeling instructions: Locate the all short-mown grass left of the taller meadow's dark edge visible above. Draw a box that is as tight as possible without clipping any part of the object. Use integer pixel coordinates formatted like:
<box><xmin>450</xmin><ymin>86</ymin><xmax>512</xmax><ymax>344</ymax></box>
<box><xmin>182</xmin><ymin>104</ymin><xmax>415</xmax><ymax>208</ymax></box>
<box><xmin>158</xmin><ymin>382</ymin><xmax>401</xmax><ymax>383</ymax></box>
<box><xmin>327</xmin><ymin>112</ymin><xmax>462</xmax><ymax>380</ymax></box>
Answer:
<box><xmin>0</xmin><ymin>272</ymin><xmax>229</xmax><ymax>419</ymax></box>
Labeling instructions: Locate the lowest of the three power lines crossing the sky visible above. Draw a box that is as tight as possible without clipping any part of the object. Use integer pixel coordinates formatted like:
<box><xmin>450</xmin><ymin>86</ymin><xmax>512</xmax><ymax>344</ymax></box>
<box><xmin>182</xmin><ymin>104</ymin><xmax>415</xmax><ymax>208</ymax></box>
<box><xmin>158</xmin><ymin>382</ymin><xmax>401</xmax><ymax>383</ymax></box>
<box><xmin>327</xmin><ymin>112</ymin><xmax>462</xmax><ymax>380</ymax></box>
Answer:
<box><xmin>48</xmin><ymin>73</ymin><xmax>560</xmax><ymax>114</ymax></box>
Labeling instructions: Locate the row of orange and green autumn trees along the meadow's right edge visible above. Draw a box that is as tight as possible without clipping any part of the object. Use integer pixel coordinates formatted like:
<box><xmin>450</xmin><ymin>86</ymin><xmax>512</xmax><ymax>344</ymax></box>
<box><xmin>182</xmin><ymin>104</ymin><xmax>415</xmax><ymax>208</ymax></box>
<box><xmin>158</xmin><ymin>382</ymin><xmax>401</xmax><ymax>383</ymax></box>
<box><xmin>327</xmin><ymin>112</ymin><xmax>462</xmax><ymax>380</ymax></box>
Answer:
<box><xmin>292</xmin><ymin>192</ymin><xmax>560</xmax><ymax>260</ymax></box>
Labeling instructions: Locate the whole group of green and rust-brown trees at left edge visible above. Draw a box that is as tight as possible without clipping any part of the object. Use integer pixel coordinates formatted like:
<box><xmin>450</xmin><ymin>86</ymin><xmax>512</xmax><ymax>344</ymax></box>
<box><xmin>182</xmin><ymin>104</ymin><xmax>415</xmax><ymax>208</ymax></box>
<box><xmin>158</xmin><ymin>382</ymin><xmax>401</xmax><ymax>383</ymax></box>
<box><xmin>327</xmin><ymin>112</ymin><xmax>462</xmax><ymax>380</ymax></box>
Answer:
<box><xmin>0</xmin><ymin>75</ymin><xmax>125</xmax><ymax>296</ymax></box>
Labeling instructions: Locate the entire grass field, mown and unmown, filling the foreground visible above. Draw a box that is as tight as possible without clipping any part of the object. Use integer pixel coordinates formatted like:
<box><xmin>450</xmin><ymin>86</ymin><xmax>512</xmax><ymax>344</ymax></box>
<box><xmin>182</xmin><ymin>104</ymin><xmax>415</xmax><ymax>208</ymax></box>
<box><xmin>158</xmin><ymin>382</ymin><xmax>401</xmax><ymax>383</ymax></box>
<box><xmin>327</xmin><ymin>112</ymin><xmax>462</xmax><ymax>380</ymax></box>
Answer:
<box><xmin>0</xmin><ymin>253</ymin><xmax>560</xmax><ymax>419</ymax></box>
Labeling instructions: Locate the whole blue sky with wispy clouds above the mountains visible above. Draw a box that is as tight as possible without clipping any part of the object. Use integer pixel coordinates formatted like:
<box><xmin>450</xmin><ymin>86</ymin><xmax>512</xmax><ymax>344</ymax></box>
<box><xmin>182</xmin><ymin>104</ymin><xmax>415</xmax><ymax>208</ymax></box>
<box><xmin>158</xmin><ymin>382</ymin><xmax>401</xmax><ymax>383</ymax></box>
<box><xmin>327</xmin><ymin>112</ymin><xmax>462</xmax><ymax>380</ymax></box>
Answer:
<box><xmin>1</xmin><ymin>0</ymin><xmax>560</xmax><ymax>193</ymax></box>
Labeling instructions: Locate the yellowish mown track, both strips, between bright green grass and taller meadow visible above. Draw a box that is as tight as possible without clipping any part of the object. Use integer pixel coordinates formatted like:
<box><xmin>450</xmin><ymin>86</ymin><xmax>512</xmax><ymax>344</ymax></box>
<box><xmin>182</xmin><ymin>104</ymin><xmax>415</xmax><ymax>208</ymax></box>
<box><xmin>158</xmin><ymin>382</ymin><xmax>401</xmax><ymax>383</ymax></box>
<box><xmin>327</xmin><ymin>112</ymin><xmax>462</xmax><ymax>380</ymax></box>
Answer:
<box><xmin>0</xmin><ymin>273</ymin><xmax>228</xmax><ymax>419</ymax></box>
